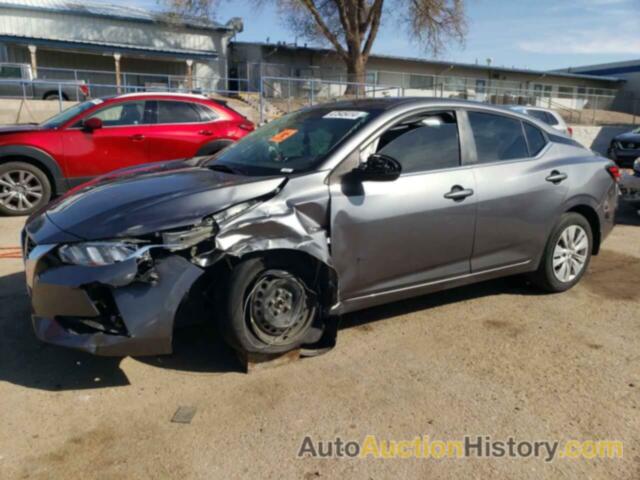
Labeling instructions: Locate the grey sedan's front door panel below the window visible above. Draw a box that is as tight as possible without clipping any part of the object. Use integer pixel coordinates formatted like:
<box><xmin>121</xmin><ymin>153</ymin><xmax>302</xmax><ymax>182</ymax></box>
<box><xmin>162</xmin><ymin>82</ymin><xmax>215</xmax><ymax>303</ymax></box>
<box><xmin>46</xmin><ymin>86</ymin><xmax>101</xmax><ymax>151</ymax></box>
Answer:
<box><xmin>331</xmin><ymin>168</ymin><xmax>476</xmax><ymax>300</ymax></box>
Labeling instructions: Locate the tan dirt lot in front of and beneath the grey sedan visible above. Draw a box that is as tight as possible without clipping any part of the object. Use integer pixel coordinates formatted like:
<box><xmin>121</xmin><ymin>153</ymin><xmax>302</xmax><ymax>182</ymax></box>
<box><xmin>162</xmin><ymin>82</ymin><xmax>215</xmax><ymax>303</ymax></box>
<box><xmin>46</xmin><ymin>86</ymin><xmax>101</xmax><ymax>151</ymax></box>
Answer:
<box><xmin>0</xmin><ymin>204</ymin><xmax>640</xmax><ymax>480</ymax></box>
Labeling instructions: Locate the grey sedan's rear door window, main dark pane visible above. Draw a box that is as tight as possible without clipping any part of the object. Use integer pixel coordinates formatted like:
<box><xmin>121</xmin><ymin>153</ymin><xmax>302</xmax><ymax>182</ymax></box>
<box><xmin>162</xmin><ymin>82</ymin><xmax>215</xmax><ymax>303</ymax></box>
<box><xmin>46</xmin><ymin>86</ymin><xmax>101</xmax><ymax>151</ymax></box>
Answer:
<box><xmin>469</xmin><ymin>111</ymin><xmax>529</xmax><ymax>163</ymax></box>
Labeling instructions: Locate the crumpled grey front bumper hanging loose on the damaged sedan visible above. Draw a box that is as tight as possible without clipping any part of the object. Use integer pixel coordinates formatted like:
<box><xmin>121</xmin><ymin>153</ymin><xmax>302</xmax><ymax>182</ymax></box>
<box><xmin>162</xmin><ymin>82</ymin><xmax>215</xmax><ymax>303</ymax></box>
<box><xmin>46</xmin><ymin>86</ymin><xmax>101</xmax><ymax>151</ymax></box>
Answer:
<box><xmin>25</xmin><ymin>245</ymin><xmax>203</xmax><ymax>356</ymax></box>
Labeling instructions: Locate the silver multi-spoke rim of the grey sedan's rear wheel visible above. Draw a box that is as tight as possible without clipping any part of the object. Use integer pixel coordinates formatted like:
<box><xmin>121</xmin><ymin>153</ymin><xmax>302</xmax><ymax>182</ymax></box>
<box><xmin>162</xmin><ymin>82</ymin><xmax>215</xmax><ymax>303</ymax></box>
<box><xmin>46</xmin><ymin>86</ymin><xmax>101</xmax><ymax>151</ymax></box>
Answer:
<box><xmin>553</xmin><ymin>225</ymin><xmax>590</xmax><ymax>283</ymax></box>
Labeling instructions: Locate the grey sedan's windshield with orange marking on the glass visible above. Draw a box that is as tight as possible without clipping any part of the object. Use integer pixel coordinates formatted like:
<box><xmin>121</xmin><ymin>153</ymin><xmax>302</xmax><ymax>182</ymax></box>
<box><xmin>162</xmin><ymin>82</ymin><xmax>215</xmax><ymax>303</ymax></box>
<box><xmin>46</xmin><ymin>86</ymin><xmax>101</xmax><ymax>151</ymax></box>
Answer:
<box><xmin>207</xmin><ymin>107</ymin><xmax>381</xmax><ymax>176</ymax></box>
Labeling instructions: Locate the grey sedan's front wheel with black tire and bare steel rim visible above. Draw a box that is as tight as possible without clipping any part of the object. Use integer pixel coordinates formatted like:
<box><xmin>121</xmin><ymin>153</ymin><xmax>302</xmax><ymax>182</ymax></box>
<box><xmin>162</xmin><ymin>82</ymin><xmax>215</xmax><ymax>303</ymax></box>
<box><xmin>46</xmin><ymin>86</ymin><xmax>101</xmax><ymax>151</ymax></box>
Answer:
<box><xmin>218</xmin><ymin>258</ymin><xmax>322</xmax><ymax>354</ymax></box>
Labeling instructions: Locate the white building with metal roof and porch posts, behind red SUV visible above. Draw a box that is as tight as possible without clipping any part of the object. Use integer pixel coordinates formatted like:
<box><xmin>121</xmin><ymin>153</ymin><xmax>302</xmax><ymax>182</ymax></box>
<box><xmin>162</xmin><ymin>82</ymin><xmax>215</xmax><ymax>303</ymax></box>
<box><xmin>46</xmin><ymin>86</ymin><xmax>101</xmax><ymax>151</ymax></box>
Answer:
<box><xmin>0</xmin><ymin>0</ymin><xmax>242</xmax><ymax>92</ymax></box>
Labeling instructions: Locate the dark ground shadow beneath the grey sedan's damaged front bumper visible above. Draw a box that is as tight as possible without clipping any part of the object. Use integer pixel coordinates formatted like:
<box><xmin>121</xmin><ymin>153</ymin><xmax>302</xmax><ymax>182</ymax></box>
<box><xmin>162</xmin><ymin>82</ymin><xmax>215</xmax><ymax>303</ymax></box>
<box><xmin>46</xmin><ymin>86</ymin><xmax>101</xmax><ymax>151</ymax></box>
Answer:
<box><xmin>0</xmin><ymin>272</ymin><xmax>242</xmax><ymax>391</ymax></box>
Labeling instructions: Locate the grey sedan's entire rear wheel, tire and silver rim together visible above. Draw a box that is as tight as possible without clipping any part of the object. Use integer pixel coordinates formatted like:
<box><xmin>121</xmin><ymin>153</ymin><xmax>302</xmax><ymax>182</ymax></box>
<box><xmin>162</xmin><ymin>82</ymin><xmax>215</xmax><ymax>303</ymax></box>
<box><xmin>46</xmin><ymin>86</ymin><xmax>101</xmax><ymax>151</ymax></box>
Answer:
<box><xmin>531</xmin><ymin>212</ymin><xmax>593</xmax><ymax>293</ymax></box>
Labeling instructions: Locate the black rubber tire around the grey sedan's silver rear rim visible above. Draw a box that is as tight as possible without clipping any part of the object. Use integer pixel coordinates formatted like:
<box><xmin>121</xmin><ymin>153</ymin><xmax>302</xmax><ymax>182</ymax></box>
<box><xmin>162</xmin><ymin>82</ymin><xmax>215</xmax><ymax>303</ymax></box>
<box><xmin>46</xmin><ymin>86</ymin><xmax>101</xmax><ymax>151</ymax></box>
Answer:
<box><xmin>530</xmin><ymin>212</ymin><xmax>593</xmax><ymax>293</ymax></box>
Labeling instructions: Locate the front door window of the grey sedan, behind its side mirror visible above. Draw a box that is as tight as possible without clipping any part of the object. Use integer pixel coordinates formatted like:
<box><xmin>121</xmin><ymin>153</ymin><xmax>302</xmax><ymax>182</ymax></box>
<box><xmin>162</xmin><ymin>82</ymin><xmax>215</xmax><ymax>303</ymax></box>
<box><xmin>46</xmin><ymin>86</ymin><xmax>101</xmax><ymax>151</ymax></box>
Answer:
<box><xmin>377</xmin><ymin>112</ymin><xmax>460</xmax><ymax>173</ymax></box>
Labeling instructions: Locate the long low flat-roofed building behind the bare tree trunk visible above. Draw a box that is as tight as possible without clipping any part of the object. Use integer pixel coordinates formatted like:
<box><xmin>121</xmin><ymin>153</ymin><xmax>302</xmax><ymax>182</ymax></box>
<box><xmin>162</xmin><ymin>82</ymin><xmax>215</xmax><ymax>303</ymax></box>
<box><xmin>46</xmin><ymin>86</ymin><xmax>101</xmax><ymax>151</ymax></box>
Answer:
<box><xmin>230</xmin><ymin>41</ymin><xmax>624</xmax><ymax>110</ymax></box>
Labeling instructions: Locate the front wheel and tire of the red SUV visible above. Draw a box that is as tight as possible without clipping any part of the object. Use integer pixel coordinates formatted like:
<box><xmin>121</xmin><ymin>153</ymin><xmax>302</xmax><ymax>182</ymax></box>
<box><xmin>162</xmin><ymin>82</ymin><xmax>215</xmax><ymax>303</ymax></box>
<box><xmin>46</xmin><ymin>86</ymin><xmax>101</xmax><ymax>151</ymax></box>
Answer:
<box><xmin>0</xmin><ymin>162</ymin><xmax>51</xmax><ymax>216</ymax></box>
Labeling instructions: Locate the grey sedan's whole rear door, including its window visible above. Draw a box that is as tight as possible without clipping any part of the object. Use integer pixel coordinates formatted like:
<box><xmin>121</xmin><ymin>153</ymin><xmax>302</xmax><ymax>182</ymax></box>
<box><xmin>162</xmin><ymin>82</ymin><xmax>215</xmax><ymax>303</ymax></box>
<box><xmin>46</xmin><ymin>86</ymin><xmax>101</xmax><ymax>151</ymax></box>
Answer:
<box><xmin>468</xmin><ymin>111</ymin><xmax>568</xmax><ymax>272</ymax></box>
